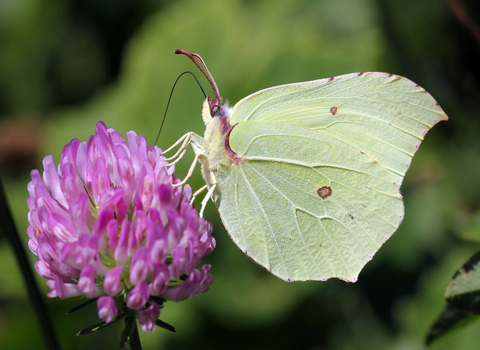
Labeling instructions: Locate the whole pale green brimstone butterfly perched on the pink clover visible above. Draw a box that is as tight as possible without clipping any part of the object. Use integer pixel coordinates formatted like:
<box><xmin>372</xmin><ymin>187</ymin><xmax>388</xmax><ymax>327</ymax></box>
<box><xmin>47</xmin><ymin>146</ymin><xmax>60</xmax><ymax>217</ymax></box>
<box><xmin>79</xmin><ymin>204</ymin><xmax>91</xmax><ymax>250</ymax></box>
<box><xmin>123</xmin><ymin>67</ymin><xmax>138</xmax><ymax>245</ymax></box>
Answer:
<box><xmin>171</xmin><ymin>50</ymin><xmax>448</xmax><ymax>282</ymax></box>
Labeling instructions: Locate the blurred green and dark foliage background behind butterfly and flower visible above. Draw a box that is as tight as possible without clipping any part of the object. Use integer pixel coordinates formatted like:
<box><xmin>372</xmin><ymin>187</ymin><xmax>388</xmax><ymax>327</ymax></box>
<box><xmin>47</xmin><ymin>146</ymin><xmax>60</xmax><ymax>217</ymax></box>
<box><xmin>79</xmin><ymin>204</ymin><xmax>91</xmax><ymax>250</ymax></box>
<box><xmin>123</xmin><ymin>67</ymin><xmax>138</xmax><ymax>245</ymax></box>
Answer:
<box><xmin>0</xmin><ymin>0</ymin><xmax>480</xmax><ymax>350</ymax></box>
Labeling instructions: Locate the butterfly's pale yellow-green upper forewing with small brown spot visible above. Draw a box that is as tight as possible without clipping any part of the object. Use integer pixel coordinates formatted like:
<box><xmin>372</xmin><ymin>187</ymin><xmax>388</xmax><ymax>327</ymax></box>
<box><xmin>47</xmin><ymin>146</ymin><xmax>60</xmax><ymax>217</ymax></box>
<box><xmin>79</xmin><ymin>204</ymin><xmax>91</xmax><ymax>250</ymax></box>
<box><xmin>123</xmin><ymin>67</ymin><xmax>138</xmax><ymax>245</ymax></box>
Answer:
<box><xmin>231</xmin><ymin>73</ymin><xmax>447</xmax><ymax>184</ymax></box>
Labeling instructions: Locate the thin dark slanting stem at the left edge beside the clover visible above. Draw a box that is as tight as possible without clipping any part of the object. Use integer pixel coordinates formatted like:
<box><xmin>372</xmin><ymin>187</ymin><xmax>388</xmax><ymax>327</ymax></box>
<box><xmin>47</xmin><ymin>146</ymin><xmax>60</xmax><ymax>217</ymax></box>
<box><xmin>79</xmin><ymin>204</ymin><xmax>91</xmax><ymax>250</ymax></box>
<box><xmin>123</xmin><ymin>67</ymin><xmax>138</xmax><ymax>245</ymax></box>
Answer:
<box><xmin>0</xmin><ymin>178</ymin><xmax>60</xmax><ymax>350</ymax></box>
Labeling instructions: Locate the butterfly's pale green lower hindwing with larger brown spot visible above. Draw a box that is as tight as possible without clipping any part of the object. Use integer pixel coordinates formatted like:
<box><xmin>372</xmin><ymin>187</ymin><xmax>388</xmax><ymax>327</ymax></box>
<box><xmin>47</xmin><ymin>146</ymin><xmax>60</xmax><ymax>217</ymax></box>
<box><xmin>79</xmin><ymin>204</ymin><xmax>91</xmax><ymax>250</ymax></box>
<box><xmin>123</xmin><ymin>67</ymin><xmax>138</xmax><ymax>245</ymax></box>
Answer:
<box><xmin>214</xmin><ymin>121</ymin><xmax>403</xmax><ymax>281</ymax></box>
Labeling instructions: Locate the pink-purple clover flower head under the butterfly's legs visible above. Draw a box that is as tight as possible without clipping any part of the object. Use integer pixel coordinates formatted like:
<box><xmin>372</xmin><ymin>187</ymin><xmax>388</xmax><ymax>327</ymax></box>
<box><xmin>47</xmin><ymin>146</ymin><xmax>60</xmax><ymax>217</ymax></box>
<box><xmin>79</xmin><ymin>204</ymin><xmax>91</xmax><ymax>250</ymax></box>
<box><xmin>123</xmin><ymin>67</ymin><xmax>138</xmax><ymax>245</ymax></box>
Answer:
<box><xmin>27</xmin><ymin>122</ymin><xmax>215</xmax><ymax>332</ymax></box>
